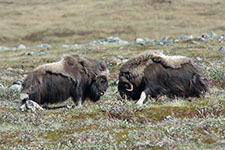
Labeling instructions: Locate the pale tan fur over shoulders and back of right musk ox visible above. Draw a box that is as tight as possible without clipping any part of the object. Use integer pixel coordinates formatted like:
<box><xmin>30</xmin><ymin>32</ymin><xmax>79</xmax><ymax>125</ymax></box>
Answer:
<box><xmin>120</xmin><ymin>51</ymin><xmax>193</xmax><ymax>83</ymax></box>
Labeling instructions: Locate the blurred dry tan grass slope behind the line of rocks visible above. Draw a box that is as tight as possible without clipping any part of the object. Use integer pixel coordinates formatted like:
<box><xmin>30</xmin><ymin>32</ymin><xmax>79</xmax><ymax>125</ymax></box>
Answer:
<box><xmin>0</xmin><ymin>0</ymin><xmax>225</xmax><ymax>46</ymax></box>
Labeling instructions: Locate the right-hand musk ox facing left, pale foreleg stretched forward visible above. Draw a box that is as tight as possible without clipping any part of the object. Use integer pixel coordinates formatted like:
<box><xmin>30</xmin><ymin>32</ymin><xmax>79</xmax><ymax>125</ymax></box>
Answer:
<box><xmin>118</xmin><ymin>51</ymin><xmax>208</xmax><ymax>105</ymax></box>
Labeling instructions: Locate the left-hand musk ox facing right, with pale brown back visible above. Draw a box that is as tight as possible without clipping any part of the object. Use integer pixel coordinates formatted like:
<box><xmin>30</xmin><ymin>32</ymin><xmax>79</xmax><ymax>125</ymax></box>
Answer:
<box><xmin>20</xmin><ymin>54</ymin><xmax>108</xmax><ymax>110</ymax></box>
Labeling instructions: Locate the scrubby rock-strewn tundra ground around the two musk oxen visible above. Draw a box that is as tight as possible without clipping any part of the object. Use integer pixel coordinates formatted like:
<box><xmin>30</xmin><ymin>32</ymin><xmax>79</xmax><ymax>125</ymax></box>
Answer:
<box><xmin>0</xmin><ymin>40</ymin><xmax>225</xmax><ymax>149</ymax></box>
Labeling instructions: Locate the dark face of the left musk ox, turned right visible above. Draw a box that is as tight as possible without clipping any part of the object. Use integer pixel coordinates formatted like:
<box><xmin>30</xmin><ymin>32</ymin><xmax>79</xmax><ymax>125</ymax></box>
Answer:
<box><xmin>87</xmin><ymin>75</ymin><xmax>108</xmax><ymax>102</ymax></box>
